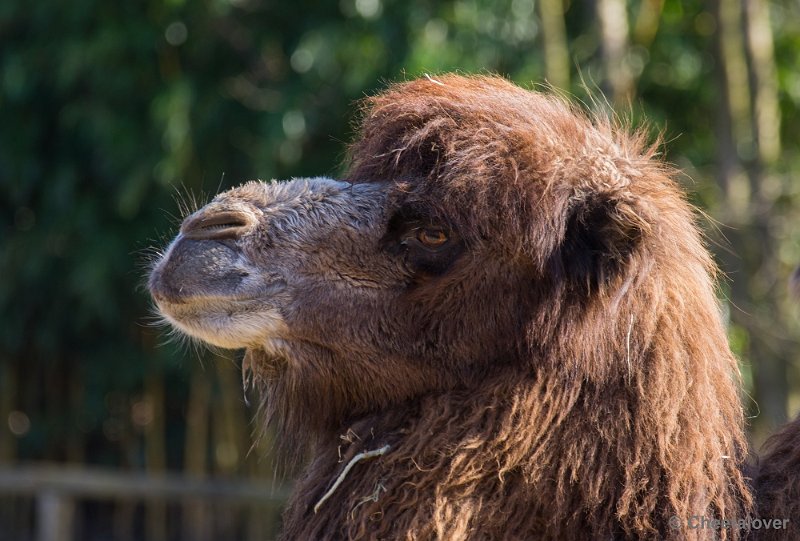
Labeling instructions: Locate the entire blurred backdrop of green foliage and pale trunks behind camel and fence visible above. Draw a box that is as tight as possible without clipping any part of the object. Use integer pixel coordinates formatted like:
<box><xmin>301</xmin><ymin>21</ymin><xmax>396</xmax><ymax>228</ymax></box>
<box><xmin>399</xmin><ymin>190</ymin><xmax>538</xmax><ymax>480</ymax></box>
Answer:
<box><xmin>0</xmin><ymin>0</ymin><xmax>800</xmax><ymax>540</ymax></box>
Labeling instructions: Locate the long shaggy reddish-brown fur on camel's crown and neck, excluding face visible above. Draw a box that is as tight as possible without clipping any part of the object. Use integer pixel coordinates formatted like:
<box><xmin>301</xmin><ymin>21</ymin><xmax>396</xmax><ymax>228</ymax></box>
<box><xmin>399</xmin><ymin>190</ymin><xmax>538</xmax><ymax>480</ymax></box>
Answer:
<box><xmin>314</xmin><ymin>77</ymin><xmax>750</xmax><ymax>539</ymax></box>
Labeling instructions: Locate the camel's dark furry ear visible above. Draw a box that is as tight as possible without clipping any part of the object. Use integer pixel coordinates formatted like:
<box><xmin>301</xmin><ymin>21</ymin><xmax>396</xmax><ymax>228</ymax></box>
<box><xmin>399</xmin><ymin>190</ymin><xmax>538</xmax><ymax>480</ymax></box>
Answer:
<box><xmin>561</xmin><ymin>192</ymin><xmax>650</xmax><ymax>293</ymax></box>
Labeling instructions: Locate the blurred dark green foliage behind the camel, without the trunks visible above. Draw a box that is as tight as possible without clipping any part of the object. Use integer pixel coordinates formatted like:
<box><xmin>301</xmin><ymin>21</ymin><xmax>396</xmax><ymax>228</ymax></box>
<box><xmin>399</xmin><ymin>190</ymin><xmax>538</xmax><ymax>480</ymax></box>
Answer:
<box><xmin>0</xmin><ymin>0</ymin><xmax>800</xmax><ymax>474</ymax></box>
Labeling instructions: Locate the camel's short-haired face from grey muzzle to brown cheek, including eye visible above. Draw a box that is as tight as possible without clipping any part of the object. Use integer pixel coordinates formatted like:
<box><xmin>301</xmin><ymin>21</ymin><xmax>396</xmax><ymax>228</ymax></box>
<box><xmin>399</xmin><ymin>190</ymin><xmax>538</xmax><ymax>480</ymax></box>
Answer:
<box><xmin>149</xmin><ymin>178</ymin><xmax>528</xmax><ymax>404</ymax></box>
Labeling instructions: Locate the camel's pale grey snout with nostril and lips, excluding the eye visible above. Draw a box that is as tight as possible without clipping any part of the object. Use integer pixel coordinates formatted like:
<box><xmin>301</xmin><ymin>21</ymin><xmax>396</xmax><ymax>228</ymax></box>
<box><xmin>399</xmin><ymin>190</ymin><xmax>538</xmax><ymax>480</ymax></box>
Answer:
<box><xmin>149</xmin><ymin>178</ymin><xmax>394</xmax><ymax>348</ymax></box>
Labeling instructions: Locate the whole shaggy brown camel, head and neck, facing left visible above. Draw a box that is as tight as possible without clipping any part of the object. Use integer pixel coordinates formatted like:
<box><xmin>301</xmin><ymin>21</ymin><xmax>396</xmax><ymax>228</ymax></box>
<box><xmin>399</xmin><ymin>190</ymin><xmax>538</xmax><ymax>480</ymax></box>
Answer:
<box><xmin>150</xmin><ymin>76</ymin><xmax>800</xmax><ymax>540</ymax></box>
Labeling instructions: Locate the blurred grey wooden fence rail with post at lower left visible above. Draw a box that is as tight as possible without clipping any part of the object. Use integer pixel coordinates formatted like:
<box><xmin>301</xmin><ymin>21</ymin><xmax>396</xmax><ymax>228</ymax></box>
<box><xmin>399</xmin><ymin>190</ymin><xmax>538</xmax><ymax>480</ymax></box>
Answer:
<box><xmin>0</xmin><ymin>465</ymin><xmax>288</xmax><ymax>541</ymax></box>
